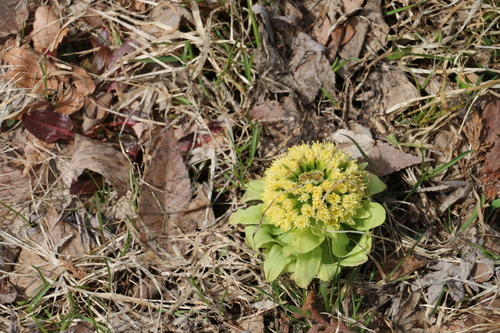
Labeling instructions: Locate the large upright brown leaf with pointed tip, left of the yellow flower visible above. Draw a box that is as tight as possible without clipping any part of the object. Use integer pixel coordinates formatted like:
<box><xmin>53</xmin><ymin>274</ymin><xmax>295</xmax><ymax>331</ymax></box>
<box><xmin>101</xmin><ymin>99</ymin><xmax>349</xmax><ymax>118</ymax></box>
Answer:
<box><xmin>139</xmin><ymin>127</ymin><xmax>196</xmax><ymax>254</ymax></box>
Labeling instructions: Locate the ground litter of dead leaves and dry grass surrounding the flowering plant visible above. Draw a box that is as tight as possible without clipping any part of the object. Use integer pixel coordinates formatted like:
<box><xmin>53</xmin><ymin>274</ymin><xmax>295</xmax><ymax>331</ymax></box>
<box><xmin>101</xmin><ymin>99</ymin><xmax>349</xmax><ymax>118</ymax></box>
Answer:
<box><xmin>0</xmin><ymin>0</ymin><xmax>500</xmax><ymax>332</ymax></box>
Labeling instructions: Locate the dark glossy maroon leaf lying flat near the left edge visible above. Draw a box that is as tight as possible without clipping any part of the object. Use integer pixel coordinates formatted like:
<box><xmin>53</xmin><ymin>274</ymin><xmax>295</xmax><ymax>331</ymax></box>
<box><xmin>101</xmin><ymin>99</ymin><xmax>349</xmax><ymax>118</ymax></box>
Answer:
<box><xmin>21</xmin><ymin>110</ymin><xmax>73</xmax><ymax>142</ymax></box>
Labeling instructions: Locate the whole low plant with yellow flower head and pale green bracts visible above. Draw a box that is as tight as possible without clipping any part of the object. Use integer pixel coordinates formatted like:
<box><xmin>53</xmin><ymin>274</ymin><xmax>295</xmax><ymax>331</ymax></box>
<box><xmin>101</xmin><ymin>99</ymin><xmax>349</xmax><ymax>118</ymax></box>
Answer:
<box><xmin>229</xmin><ymin>143</ymin><xmax>386</xmax><ymax>288</ymax></box>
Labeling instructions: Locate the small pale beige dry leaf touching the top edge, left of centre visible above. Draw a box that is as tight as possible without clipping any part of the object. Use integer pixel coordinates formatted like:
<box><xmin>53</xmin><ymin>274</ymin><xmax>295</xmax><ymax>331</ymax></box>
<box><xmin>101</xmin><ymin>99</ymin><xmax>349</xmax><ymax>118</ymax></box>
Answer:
<box><xmin>142</xmin><ymin>1</ymin><xmax>181</xmax><ymax>34</ymax></box>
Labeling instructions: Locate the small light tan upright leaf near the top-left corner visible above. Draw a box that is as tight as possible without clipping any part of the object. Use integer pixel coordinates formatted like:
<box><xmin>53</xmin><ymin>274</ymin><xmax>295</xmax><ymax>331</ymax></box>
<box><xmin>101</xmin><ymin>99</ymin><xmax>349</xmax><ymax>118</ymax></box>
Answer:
<box><xmin>31</xmin><ymin>6</ymin><xmax>68</xmax><ymax>52</ymax></box>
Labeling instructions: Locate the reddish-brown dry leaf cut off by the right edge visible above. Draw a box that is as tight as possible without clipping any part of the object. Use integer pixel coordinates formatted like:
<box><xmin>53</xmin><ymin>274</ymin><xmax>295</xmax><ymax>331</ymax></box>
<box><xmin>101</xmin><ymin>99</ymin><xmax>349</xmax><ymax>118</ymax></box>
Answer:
<box><xmin>482</xmin><ymin>96</ymin><xmax>500</xmax><ymax>199</ymax></box>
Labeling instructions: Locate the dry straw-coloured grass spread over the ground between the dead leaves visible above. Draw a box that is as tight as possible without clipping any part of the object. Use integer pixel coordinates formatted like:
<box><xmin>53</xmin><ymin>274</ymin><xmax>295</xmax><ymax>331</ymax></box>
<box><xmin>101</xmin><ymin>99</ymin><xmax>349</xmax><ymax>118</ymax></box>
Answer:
<box><xmin>0</xmin><ymin>0</ymin><xmax>500</xmax><ymax>332</ymax></box>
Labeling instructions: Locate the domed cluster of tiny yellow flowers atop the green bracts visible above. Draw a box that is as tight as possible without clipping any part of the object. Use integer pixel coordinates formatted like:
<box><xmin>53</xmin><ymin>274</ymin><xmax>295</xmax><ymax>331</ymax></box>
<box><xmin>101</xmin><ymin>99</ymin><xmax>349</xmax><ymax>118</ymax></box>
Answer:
<box><xmin>262</xmin><ymin>143</ymin><xmax>366</xmax><ymax>231</ymax></box>
